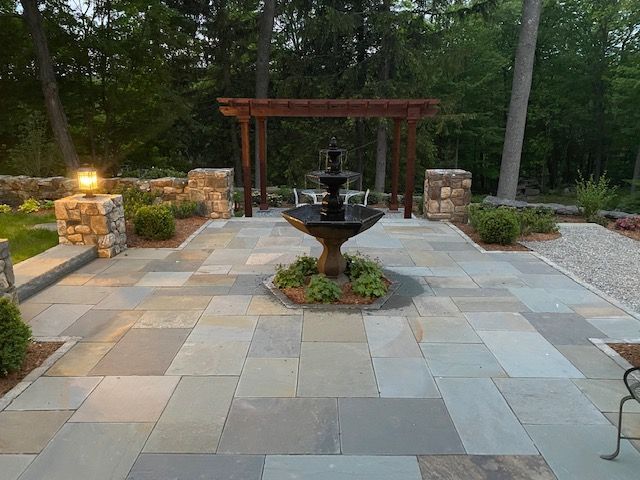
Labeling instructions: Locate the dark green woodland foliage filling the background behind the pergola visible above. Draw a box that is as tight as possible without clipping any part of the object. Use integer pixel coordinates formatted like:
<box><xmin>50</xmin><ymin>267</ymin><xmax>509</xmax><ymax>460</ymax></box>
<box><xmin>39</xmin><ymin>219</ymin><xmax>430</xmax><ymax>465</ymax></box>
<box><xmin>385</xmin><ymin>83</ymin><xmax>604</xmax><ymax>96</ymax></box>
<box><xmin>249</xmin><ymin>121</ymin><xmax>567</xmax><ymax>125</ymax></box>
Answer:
<box><xmin>0</xmin><ymin>0</ymin><xmax>640</xmax><ymax>199</ymax></box>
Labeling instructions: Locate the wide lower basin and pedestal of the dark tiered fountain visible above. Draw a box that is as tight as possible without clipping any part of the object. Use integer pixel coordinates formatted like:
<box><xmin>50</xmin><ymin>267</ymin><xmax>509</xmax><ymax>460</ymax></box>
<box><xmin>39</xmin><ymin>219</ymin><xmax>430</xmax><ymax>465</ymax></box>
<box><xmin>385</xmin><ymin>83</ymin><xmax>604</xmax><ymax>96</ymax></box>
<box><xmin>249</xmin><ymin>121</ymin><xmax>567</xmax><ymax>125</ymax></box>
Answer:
<box><xmin>282</xmin><ymin>205</ymin><xmax>384</xmax><ymax>278</ymax></box>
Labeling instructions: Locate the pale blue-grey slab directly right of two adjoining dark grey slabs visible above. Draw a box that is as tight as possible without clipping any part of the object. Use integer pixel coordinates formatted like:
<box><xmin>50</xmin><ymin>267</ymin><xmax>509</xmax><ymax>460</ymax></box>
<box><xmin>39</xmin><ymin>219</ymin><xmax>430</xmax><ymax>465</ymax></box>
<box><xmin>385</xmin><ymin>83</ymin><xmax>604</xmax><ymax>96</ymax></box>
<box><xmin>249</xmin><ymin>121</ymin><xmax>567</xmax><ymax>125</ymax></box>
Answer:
<box><xmin>437</xmin><ymin>378</ymin><xmax>538</xmax><ymax>455</ymax></box>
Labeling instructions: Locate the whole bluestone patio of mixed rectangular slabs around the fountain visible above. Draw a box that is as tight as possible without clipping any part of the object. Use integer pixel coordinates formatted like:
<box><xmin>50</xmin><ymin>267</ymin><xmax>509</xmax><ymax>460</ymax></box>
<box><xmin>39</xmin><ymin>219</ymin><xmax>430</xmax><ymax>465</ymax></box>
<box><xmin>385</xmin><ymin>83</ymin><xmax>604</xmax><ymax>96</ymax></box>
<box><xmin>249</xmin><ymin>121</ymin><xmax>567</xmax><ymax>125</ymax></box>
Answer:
<box><xmin>0</xmin><ymin>217</ymin><xmax>640</xmax><ymax>480</ymax></box>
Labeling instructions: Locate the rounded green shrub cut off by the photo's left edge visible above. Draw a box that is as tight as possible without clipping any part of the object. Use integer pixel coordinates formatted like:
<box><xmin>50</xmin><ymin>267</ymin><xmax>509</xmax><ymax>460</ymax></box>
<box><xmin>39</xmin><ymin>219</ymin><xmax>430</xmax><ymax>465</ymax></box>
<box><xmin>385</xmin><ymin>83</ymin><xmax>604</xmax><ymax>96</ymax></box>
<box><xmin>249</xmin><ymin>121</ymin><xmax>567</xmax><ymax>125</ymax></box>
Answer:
<box><xmin>0</xmin><ymin>298</ymin><xmax>31</xmax><ymax>376</ymax></box>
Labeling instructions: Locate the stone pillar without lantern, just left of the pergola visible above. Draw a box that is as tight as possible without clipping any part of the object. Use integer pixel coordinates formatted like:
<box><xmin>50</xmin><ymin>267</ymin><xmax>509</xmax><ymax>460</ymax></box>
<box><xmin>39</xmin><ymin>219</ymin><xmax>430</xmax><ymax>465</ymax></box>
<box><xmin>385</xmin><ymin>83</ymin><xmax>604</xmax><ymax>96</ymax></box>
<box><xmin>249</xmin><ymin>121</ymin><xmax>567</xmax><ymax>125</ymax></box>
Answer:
<box><xmin>185</xmin><ymin>168</ymin><xmax>233</xmax><ymax>218</ymax></box>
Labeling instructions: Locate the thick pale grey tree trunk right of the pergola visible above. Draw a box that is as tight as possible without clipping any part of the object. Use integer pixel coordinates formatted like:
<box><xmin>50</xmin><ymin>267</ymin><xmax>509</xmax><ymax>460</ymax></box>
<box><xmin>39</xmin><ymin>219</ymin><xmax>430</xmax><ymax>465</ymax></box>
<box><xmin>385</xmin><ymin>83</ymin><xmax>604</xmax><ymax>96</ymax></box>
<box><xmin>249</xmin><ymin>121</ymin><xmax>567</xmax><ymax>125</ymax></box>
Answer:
<box><xmin>498</xmin><ymin>0</ymin><xmax>542</xmax><ymax>200</ymax></box>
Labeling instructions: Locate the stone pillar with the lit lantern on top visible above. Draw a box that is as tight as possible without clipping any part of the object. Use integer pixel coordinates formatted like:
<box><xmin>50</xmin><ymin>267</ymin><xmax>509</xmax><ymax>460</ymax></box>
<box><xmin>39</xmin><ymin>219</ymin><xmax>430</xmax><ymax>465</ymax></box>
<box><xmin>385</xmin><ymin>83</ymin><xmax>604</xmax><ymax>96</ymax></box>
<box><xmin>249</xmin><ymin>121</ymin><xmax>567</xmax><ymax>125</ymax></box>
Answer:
<box><xmin>55</xmin><ymin>194</ymin><xmax>127</xmax><ymax>258</ymax></box>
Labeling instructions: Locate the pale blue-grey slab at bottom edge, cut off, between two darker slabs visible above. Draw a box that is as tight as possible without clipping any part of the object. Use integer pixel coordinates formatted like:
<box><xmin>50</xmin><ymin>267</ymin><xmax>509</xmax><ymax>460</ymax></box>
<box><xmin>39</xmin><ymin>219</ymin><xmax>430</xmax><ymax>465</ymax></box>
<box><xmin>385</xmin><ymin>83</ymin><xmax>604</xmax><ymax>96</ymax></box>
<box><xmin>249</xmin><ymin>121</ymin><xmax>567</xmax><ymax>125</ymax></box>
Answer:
<box><xmin>262</xmin><ymin>455</ymin><xmax>422</xmax><ymax>480</ymax></box>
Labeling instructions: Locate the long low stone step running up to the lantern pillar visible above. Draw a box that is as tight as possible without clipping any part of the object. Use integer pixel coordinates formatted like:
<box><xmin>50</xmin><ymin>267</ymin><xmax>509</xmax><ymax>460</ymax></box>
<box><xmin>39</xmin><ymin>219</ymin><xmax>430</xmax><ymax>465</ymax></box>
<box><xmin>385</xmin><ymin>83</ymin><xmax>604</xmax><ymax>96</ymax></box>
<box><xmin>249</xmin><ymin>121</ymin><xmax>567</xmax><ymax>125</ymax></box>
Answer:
<box><xmin>13</xmin><ymin>245</ymin><xmax>98</xmax><ymax>302</ymax></box>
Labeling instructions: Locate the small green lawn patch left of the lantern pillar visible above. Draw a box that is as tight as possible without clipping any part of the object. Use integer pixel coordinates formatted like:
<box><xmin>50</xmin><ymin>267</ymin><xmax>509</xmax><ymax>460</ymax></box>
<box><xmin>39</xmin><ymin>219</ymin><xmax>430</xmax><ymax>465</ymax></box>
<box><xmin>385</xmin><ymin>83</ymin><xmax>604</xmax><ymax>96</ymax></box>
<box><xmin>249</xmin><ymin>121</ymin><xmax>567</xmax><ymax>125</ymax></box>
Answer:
<box><xmin>0</xmin><ymin>211</ymin><xmax>58</xmax><ymax>263</ymax></box>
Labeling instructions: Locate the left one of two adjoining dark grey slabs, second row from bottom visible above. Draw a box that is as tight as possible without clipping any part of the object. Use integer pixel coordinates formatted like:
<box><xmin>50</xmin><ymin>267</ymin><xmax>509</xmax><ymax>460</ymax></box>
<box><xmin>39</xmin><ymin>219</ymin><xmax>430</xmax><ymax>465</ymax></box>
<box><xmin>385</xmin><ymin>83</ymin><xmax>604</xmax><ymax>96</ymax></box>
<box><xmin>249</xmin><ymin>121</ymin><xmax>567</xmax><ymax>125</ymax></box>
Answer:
<box><xmin>218</xmin><ymin>398</ymin><xmax>340</xmax><ymax>454</ymax></box>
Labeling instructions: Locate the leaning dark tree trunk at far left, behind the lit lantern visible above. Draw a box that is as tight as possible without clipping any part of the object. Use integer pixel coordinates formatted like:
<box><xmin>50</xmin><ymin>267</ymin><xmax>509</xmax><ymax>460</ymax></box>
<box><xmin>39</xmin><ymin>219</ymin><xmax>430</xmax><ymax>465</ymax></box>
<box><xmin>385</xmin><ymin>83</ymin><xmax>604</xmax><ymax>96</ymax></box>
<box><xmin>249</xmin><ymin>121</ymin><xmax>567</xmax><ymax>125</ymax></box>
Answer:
<box><xmin>20</xmin><ymin>0</ymin><xmax>78</xmax><ymax>171</ymax></box>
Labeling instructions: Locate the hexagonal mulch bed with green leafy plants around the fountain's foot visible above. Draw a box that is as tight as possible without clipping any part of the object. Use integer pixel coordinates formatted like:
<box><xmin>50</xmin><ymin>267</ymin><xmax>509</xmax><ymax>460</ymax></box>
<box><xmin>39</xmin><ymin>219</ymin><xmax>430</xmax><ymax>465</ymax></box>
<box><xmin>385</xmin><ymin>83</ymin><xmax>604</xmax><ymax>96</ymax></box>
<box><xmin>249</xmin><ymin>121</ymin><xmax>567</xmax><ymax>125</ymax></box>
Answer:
<box><xmin>265</xmin><ymin>255</ymin><xmax>398</xmax><ymax>310</ymax></box>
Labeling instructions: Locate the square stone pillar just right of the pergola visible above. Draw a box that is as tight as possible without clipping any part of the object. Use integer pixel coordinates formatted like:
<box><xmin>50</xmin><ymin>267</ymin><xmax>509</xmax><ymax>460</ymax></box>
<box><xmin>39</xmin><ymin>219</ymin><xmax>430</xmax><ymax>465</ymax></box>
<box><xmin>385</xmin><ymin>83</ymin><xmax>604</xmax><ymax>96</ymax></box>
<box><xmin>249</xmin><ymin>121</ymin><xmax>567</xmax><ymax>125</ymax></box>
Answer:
<box><xmin>424</xmin><ymin>168</ymin><xmax>471</xmax><ymax>223</ymax></box>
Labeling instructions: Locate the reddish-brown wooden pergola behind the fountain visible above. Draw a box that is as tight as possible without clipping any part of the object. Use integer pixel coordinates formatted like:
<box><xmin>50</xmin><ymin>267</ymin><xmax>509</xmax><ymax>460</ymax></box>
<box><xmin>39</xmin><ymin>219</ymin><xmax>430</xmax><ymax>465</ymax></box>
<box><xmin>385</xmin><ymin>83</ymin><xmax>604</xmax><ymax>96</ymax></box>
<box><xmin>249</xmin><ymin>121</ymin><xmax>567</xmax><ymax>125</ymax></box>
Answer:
<box><xmin>218</xmin><ymin>98</ymin><xmax>439</xmax><ymax>218</ymax></box>
